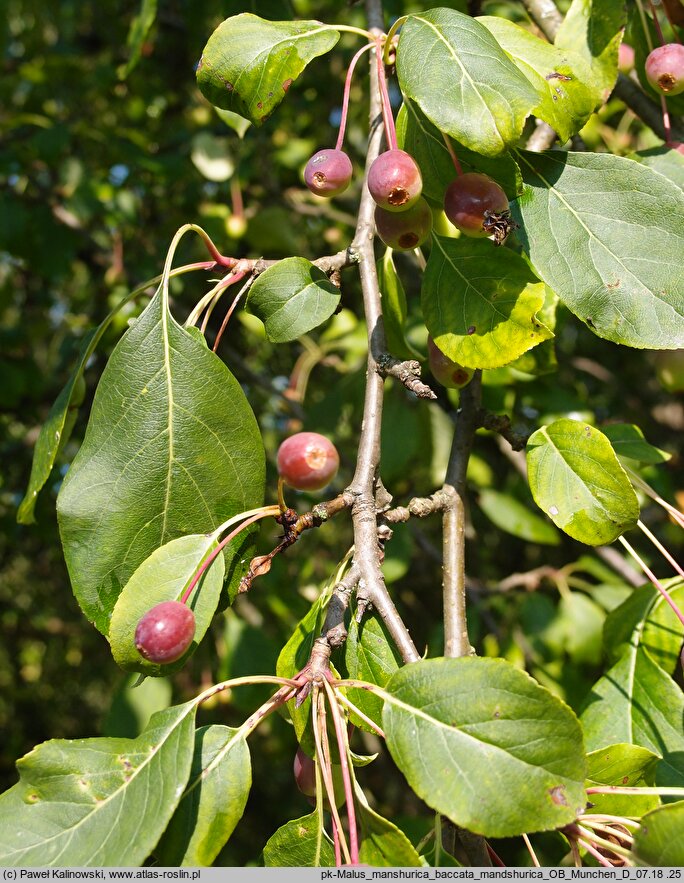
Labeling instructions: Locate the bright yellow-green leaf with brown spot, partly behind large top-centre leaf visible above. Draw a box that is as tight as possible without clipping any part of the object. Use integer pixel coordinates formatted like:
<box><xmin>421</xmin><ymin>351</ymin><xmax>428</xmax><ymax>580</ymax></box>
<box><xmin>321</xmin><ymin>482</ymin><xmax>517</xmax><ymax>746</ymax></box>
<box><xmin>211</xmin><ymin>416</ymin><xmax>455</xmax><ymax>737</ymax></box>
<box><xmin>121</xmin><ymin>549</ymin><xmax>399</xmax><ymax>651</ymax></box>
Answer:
<box><xmin>477</xmin><ymin>15</ymin><xmax>604</xmax><ymax>142</ymax></box>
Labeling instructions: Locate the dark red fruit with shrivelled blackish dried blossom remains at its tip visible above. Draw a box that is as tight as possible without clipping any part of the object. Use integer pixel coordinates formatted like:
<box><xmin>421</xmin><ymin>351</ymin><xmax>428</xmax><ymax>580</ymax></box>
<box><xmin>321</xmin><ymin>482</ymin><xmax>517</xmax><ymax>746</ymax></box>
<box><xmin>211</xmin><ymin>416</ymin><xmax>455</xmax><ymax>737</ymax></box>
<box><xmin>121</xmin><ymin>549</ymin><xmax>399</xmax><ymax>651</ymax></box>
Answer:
<box><xmin>444</xmin><ymin>172</ymin><xmax>515</xmax><ymax>245</ymax></box>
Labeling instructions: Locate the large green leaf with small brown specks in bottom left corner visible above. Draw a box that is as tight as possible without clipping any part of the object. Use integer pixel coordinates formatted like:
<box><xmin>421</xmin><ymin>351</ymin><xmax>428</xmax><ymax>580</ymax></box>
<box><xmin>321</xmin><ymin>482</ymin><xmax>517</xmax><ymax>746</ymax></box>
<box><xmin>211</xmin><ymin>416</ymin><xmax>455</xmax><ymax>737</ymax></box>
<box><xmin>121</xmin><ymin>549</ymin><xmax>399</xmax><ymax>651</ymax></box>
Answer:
<box><xmin>0</xmin><ymin>702</ymin><xmax>196</xmax><ymax>867</ymax></box>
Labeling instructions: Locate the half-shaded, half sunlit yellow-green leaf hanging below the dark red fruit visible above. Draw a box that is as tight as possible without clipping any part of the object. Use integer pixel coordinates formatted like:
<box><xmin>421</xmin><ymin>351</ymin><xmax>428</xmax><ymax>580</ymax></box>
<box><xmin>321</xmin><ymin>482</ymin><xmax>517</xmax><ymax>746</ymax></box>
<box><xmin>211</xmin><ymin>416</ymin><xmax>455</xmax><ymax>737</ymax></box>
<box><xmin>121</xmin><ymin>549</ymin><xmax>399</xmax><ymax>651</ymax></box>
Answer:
<box><xmin>421</xmin><ymin>234</ymin><xmax>553</xmax><ymax>368</ymax></box>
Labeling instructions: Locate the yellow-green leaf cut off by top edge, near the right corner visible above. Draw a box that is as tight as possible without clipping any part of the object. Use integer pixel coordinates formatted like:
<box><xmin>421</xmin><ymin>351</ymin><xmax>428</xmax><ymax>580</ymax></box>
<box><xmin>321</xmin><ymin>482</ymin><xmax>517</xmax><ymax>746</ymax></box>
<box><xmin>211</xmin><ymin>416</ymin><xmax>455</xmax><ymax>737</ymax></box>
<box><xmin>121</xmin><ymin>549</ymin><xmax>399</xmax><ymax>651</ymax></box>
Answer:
<box><xmin>555</xmin><ymin>0</ymin><xmax>627</xmax><ymax>104</ymax></box>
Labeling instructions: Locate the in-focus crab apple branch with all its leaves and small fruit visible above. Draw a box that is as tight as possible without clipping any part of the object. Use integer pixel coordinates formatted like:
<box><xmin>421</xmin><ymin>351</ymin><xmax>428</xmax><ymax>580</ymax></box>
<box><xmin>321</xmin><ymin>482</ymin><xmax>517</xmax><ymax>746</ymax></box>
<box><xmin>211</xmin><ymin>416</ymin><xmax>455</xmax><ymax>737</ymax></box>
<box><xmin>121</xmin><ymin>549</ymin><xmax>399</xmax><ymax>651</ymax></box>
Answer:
<box><xmin>5</xmin><ymin>0</ymin><xmax>684</xmax><ymax>867</ymax></box>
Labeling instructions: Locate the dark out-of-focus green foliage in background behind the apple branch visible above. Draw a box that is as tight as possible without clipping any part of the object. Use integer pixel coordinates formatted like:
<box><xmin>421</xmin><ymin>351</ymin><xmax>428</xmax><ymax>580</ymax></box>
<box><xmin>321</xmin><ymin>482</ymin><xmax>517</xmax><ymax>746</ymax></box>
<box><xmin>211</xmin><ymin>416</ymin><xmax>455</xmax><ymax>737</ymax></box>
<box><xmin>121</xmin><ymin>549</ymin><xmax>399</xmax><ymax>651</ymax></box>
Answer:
<box><xmin>0</xmin><ymin>0</ymin><xmax>684</xmax><ymax>865</ymax></box>
